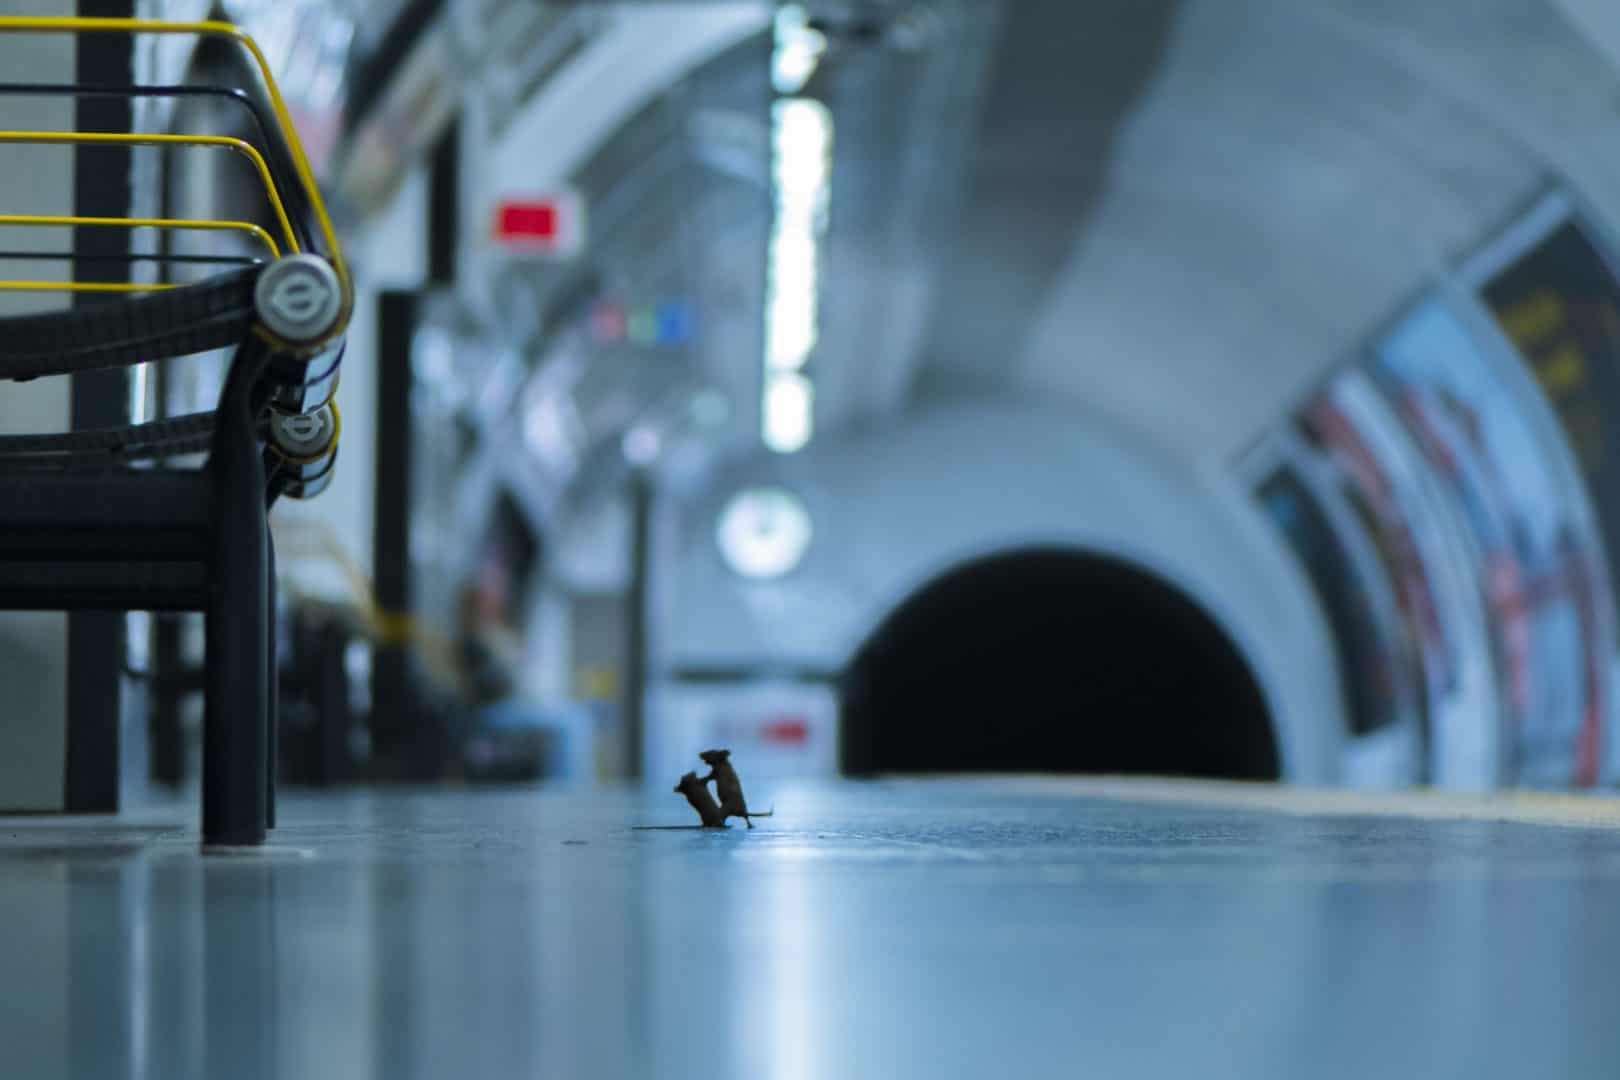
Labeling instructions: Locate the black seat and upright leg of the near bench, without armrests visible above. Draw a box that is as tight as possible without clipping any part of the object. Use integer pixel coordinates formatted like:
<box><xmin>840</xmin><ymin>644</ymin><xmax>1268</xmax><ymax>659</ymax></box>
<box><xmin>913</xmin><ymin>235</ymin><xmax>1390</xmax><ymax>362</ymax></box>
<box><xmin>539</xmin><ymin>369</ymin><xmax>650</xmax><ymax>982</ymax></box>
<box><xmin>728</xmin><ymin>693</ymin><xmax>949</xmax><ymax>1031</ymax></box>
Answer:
<box><xmin>0</xmin><ymin>342</ymin><xmax>275</xmax><ymax>844</ymax></box>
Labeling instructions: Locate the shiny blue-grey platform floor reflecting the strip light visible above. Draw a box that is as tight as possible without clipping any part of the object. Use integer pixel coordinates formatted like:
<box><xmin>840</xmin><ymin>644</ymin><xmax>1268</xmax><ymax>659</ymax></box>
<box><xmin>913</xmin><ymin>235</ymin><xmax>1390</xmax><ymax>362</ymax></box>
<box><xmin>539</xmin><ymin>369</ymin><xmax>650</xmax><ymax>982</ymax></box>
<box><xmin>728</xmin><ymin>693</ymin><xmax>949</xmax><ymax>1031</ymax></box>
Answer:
<box><xmin>0</xmin><ymin>780</ymin><xmax>1620</xmax><ymax>1080</ymax></box>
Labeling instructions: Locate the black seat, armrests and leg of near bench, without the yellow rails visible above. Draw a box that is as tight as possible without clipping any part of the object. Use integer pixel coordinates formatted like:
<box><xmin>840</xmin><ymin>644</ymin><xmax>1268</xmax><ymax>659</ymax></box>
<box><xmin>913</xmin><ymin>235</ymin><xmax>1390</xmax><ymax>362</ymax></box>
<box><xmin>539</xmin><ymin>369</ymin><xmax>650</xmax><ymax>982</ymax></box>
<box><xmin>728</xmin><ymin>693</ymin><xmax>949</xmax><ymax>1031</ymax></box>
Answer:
<box><xmin>0</xmin><ymin>256</ymin><xmax>342</xmax><ymax>845</ymax></box>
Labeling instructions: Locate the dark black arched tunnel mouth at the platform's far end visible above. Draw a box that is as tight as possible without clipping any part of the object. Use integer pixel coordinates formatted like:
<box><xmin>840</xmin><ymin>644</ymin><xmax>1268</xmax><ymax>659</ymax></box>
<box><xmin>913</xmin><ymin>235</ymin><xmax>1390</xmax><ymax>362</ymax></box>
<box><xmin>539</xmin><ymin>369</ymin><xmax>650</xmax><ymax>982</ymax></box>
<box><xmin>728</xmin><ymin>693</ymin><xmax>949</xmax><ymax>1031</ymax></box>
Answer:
<box><xmin>839</xmin><ymin>547</ymin><xmax>1280</xmax><ymax>780</ymax></box>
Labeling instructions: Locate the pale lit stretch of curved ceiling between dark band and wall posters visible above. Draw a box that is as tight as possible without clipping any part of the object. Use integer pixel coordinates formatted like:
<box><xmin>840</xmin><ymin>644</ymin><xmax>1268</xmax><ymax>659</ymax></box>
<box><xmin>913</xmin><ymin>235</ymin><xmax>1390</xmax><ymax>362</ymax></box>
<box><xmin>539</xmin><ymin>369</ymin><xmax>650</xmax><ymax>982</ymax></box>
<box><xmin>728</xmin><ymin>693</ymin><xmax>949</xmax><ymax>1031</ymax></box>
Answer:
<box><xmin>925</xmin><ymin>0</ymin><xmax>1620</xmax><ymax>458</ymax></box>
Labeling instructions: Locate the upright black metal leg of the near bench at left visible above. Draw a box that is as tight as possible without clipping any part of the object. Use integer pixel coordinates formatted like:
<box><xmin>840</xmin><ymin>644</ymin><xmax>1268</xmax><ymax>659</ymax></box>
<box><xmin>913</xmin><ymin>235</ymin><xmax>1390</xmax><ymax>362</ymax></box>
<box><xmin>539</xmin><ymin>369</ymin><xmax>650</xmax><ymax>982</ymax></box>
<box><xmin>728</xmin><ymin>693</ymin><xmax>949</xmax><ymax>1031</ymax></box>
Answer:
<box><xmin>203</xmin><ymin>345</ymin><xmax>271</xmax><ymax>844</ymax></box>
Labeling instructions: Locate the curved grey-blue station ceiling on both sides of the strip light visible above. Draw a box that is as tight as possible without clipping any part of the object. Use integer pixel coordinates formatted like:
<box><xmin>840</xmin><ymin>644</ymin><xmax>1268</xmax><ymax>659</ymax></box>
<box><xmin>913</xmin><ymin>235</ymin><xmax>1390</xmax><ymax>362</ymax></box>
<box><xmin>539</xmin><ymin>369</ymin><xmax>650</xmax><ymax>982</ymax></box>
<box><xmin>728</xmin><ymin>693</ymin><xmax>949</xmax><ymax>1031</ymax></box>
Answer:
<box><xmin>427</xmin><ymin>0</ymin><xmax>1620</xmax><ymax>508</ymax></box>
